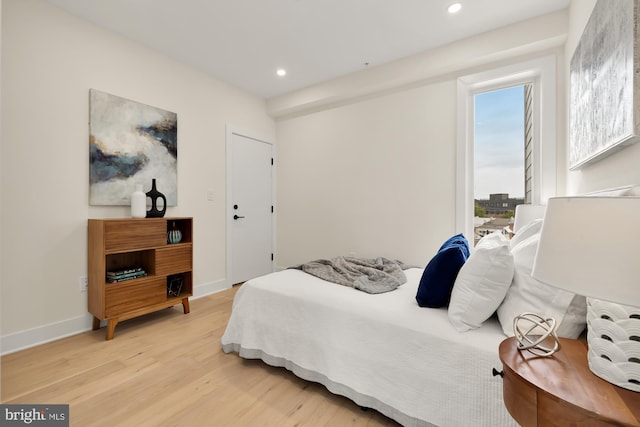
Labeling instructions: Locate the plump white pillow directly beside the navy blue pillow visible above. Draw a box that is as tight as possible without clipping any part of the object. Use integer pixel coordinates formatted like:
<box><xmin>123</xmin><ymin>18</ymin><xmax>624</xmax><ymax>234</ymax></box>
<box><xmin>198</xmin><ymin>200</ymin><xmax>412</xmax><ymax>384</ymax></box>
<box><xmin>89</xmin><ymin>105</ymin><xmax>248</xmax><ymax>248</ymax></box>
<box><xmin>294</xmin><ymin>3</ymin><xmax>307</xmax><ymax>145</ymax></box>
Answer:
<box><xmin>448</xmin><ymin>232</ymin><xmax>513</xmax><ymax>332</ymax></box>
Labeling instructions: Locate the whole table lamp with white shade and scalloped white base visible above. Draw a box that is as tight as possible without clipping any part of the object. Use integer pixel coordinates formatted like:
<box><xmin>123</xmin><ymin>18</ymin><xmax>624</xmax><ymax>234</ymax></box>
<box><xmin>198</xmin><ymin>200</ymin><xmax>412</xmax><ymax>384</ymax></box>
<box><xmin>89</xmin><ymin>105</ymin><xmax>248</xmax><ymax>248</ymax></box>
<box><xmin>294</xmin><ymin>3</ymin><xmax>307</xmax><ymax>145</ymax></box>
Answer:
<box><xmin>532</xmin><ymin>197</ymin><xmax>640</xmax><ymax>391</ymax></box>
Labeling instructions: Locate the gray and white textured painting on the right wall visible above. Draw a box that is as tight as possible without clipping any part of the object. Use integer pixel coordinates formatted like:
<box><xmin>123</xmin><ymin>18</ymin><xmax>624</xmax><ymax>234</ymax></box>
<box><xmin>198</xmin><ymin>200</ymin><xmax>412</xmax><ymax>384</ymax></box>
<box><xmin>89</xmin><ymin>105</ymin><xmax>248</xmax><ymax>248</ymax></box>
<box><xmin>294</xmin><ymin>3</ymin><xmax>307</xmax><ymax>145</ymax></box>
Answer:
<box><xmin>569</xmin><ymin>0</ymin><xmax>640</xmax><ymax>170</ymax></box>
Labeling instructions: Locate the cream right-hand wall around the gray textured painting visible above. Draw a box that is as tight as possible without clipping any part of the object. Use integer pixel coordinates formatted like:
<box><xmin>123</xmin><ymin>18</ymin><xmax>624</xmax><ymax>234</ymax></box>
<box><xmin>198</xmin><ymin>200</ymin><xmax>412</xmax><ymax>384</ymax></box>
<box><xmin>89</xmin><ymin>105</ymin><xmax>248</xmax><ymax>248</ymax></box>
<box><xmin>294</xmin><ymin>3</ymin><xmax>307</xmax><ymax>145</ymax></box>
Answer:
<box><xmin>564</xmin><ymin>0</ymin><xmax>640</xmax><ymax>195</ymax></box>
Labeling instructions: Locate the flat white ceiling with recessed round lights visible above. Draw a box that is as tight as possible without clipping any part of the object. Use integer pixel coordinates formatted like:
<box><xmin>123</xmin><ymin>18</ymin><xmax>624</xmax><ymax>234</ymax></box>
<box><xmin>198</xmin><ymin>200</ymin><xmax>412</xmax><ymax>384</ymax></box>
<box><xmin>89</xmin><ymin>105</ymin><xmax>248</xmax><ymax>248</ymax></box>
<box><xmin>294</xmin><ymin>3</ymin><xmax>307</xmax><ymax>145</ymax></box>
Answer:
<box><xmin>48</xmin><ymin>0</ymin><xmax>570</xmax><ymax>98</ymax></box>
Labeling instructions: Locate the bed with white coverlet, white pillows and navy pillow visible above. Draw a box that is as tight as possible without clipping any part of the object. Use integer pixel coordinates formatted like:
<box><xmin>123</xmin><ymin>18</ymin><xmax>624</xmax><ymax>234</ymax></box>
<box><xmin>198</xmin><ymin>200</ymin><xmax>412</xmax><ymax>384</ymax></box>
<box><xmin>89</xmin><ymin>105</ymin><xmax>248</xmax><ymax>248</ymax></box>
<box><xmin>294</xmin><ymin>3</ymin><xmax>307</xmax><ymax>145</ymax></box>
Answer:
<box><xmin>221</xmin><ymin>185</ymin><xmax>640</xmax><ymax>427</ymax></box>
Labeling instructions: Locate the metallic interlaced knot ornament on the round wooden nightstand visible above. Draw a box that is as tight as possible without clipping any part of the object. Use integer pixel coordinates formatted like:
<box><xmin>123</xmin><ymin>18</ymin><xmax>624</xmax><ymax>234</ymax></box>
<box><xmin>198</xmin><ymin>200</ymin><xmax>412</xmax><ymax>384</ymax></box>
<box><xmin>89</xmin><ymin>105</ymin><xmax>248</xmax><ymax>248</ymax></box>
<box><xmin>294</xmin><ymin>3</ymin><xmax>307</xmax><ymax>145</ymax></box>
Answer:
<box><xmin>513</xmin><ymin>313</ymin><xmax>560</xmax><ymax>357</ymax></box>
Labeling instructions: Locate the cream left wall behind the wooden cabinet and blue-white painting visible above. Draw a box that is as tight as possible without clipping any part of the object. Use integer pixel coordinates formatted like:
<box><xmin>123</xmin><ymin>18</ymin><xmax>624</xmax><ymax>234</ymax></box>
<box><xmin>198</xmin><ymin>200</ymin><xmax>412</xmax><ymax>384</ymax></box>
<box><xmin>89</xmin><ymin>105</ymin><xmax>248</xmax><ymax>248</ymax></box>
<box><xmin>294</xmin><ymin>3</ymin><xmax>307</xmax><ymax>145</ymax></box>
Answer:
<box><xmin>0</xmin><ymin>0</ymin><xmax>275</xmax><ymax>352</ymax></box>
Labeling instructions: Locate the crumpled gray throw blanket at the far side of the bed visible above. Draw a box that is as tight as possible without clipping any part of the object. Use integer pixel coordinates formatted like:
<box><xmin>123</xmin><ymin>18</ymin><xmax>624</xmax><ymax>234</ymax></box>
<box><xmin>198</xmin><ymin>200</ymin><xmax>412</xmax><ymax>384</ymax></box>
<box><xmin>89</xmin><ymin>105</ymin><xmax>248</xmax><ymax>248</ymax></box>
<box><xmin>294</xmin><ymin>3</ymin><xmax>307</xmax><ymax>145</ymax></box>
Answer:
<box><xmin>291</xmin><ymin>256</ymin><xmax>412</xmax><ymax>294</ymax></box>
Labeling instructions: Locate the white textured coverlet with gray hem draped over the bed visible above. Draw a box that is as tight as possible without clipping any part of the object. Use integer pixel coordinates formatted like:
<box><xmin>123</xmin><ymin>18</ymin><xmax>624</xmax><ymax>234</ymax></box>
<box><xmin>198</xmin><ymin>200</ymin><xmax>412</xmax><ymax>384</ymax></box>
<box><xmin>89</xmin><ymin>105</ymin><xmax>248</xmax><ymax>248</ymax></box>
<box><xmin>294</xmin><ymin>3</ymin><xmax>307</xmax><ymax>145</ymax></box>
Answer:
<box><xmin>221</xmin><ymin>268</ymin><xmax>516</xmax><ymax>427</ymax></box>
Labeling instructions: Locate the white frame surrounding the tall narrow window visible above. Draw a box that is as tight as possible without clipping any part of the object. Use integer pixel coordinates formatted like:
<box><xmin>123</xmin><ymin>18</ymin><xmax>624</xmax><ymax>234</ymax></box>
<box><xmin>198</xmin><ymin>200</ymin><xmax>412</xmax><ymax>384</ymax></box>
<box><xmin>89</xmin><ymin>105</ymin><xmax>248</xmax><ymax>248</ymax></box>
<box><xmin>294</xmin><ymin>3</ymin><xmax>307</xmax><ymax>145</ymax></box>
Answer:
<box><xmin>456</xmin><ymin>56</ymin><xmax>556</xmax><ymax>241</ymax></box>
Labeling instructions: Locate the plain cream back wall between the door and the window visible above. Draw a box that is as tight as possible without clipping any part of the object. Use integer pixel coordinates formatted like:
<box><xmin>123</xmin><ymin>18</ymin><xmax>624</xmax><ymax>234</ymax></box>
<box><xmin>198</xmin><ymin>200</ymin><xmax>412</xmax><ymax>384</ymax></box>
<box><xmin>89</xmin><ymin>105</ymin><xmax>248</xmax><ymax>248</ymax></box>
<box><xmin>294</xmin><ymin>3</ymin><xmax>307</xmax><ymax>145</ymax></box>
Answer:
<box><xmin>276</xmin><ymin>81</ymin><xmax>456</xmax><ymax>267</ymax></box>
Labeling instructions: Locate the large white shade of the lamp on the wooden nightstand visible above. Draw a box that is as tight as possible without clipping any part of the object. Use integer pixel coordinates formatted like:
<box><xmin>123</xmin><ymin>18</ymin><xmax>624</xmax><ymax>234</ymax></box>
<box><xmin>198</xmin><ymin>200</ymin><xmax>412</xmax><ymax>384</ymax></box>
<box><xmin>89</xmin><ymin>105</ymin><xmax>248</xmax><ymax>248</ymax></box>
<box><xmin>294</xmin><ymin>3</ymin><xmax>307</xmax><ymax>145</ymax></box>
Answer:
<box><xmin>532</xmin><ymin>197</ymin><xmax>640</xmax><ymax>306</ymax></box>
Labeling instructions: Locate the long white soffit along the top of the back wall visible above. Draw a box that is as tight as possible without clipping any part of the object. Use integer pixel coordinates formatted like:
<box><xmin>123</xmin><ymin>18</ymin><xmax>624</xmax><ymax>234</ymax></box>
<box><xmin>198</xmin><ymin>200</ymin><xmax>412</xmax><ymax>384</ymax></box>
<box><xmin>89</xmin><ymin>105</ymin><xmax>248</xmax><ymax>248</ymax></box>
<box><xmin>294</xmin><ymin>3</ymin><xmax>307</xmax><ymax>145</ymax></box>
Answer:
<box><xmin>267</xmin><ymin>10</ymin><xmax>568</xmax><ymax>119</ymax></box>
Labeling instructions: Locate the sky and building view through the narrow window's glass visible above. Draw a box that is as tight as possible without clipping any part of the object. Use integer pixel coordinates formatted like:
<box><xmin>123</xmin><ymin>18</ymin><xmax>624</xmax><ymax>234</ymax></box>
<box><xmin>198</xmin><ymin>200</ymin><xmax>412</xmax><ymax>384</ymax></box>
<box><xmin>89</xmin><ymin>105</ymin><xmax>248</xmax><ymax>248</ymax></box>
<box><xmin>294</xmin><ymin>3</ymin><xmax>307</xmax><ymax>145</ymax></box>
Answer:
<box><xmin>474</xmin><ymin>85</ymin><xmax>530</xmax><ymax>243</ymax></box>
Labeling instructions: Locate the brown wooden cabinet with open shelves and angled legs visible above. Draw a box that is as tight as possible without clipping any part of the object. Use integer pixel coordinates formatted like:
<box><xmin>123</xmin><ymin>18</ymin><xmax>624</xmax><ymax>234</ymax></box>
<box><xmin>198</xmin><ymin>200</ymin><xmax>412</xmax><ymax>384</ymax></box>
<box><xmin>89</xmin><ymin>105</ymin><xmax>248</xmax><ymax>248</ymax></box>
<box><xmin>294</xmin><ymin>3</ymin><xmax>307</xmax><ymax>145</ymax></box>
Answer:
<box><xmin>88</xmin><ymin>217</ymin><xmax>193</xmax><ymax>340</ymax></box>
